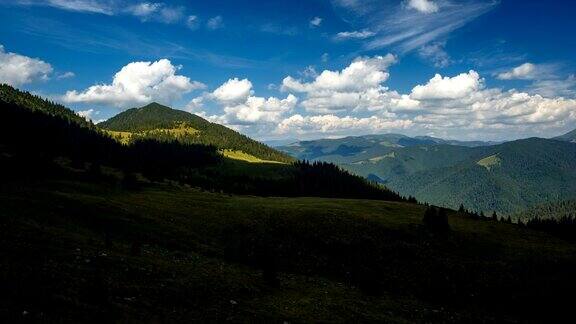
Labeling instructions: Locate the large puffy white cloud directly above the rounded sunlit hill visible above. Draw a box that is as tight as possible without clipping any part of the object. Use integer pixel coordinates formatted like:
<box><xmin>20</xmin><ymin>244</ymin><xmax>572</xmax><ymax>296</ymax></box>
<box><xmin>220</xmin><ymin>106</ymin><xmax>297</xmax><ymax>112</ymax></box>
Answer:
<box><xmin>62</xmin><ymin>59</ymin><xmax>205</xmax><ymax>108</ymax></box>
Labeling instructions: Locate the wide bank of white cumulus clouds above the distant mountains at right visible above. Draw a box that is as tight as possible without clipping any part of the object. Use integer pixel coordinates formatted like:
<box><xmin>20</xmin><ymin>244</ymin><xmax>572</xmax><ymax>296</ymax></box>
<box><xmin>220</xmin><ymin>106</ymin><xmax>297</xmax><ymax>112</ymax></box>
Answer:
<box><xmin>274</xmin><ymin>55</ymin><xmax>576</xmax><ymax>140</ymax></box>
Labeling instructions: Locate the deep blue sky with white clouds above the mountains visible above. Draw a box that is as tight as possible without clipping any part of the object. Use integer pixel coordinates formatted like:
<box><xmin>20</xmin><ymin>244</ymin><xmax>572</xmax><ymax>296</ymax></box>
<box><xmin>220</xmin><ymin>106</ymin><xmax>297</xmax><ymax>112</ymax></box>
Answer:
<box><xmin>0</xmin><ymin>0</ymin><xmax>576</xmax><ymax>141</ymax></box>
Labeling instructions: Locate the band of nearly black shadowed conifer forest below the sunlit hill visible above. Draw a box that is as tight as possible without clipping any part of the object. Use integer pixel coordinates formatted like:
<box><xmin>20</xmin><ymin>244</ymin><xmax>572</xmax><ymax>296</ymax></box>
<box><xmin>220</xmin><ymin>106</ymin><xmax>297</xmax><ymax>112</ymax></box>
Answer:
<box><xmin>0</xmin><ymin>88</ymin><xmax>402</xmax><ymax>200</ymax></box>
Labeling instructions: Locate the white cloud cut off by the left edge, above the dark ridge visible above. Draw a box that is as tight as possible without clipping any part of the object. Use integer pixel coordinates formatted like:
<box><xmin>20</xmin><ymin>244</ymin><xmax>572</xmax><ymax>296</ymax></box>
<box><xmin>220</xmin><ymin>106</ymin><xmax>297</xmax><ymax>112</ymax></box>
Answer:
<box><xmin>0</xmin><ymin>45</ymin><xmax>53</xmax><ymax>86</ymax></box>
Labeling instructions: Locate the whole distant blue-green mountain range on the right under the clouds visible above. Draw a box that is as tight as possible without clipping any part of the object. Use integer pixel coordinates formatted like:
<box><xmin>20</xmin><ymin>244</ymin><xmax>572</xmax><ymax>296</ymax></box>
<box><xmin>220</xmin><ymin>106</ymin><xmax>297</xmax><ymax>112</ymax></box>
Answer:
<box><xmin>278</xmin><ymin>131</ymin><xmax>576</xmax><ymax>214</ymax></box>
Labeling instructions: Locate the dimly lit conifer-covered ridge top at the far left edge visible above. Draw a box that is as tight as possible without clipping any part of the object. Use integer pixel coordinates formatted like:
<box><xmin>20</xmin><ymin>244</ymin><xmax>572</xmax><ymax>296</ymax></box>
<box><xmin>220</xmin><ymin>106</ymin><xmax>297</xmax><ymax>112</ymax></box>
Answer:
<box><xmin>0</xmin><ymin>84</ymin><xmax>92</xmax><ymax>126</ymax></box>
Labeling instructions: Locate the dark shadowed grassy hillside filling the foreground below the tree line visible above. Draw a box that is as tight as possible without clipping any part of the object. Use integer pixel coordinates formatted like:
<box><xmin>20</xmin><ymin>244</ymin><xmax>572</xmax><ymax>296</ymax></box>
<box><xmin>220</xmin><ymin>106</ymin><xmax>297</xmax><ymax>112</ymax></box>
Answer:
<box><xmin>0</xmin><ymin>176</ymin><xmax>576</xmax><ymax>323</ymax></box>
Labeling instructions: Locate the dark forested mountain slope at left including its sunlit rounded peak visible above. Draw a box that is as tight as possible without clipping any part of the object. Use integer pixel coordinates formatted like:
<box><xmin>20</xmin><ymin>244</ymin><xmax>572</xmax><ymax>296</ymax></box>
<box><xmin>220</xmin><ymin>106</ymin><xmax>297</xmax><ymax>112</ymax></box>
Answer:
<box><xmin>0</xmin><ymin>87</ymin><xmax>402</xmax><ymax>201</ymax></box>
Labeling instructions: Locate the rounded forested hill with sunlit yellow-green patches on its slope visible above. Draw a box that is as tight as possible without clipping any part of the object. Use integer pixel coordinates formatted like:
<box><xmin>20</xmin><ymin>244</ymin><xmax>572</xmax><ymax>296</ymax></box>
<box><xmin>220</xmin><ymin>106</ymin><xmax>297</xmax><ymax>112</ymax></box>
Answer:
<box><xmin>98</xmin><ymin>103</ymin><xmax>294</xmax><ymax>162</ymax></box>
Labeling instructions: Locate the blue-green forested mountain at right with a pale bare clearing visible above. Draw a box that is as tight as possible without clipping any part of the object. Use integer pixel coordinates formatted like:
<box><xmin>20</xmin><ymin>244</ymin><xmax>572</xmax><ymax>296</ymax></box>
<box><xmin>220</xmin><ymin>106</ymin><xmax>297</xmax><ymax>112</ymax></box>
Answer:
<box><xmin>382</xmin><ymin>138</ymin><xmax>576</xmax><ymax>214</ymax></box>
